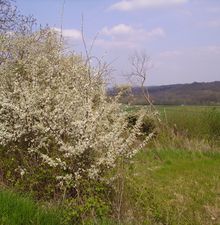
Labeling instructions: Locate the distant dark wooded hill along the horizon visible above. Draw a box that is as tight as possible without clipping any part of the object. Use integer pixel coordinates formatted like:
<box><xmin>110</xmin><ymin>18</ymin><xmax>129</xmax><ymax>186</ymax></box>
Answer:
<box><xmin>111</xmin><ymin>81</ymin><xmax>220</xmax><ymax>105</ymax></box>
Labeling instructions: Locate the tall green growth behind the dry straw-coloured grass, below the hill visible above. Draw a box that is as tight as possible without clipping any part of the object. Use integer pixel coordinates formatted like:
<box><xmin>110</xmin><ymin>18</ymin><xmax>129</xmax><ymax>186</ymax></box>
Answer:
<box><xmin>158</xmin><ymin>106</ymin><xmax>220</xmax><ymax>145</ymax></box>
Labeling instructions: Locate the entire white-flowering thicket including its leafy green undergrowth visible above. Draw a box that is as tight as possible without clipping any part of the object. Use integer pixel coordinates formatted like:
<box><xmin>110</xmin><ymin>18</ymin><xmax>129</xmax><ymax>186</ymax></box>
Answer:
<box><xmin>0</xmin><ymin>1</ymin><xmax>156</xmax><ymax>223</ymax></box>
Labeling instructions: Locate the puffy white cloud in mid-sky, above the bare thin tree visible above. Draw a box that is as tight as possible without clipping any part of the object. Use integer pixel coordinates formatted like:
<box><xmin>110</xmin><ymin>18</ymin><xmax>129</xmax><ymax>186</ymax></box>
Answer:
<box><xmin>96</xmin><ymin>24</ymin><xmax>166</xmax><ymax>48</ymax></box>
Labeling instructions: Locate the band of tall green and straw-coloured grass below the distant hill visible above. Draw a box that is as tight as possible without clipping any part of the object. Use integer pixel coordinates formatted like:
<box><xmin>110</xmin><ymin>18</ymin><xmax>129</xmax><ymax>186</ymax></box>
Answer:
<box><xmin>125</xmin><ymin>106</ymin><xmax>220</xmax><ymax>150</ymax></box>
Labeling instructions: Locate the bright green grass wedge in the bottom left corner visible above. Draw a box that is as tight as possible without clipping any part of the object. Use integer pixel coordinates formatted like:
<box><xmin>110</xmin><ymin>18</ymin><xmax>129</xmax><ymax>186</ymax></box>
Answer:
<box><xmin>0</xmin><ymin>190</ymin><xmax>61</xmax><ymax>225</ymax></box>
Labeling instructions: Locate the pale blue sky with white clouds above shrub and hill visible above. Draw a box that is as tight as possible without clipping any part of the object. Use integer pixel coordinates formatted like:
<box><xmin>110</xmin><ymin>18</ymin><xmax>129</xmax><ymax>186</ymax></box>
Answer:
<box><xmin>17</xmin><ymin>0</ymin><xmax>220</xmax><ymax>85</ymax></box>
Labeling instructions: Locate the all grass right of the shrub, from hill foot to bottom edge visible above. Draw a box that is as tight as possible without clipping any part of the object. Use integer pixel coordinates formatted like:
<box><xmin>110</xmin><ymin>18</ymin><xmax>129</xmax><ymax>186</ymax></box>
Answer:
<box><xmin>113</xmin><ymin>106</ymin><xmax>220</xmax><ymax>225</ymax></box>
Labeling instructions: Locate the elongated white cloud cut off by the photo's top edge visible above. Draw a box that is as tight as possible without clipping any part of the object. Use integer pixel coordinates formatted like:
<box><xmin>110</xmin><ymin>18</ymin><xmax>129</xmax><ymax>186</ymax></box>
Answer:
<box><xmin>109</xmin><ymin>0</ymin><xmax>189</xmax><ymax>11</ymax></box>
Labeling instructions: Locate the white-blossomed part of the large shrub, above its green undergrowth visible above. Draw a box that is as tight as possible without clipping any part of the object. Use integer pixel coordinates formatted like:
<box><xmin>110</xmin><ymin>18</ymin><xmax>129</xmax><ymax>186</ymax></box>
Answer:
<box><xmin>0</xmin><ymin>30</ymin><xmax>152</xmax><ymax>187</ymax></box>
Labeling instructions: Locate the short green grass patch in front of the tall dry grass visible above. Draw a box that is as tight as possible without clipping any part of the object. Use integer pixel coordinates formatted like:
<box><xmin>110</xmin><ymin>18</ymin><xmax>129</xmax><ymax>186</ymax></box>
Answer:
<box><xmin>124</xmin><ymin>149</ymin><xmax>220</xmax><ymax>225</ymax></box>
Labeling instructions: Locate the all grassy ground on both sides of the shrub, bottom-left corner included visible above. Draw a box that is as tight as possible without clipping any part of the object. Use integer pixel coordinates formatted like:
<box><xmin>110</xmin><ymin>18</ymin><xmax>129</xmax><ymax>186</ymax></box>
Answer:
<box><xmin>0</xmin><ymin>106</ymin><xmax>220</xmax><ymax>225</ymax></box>
